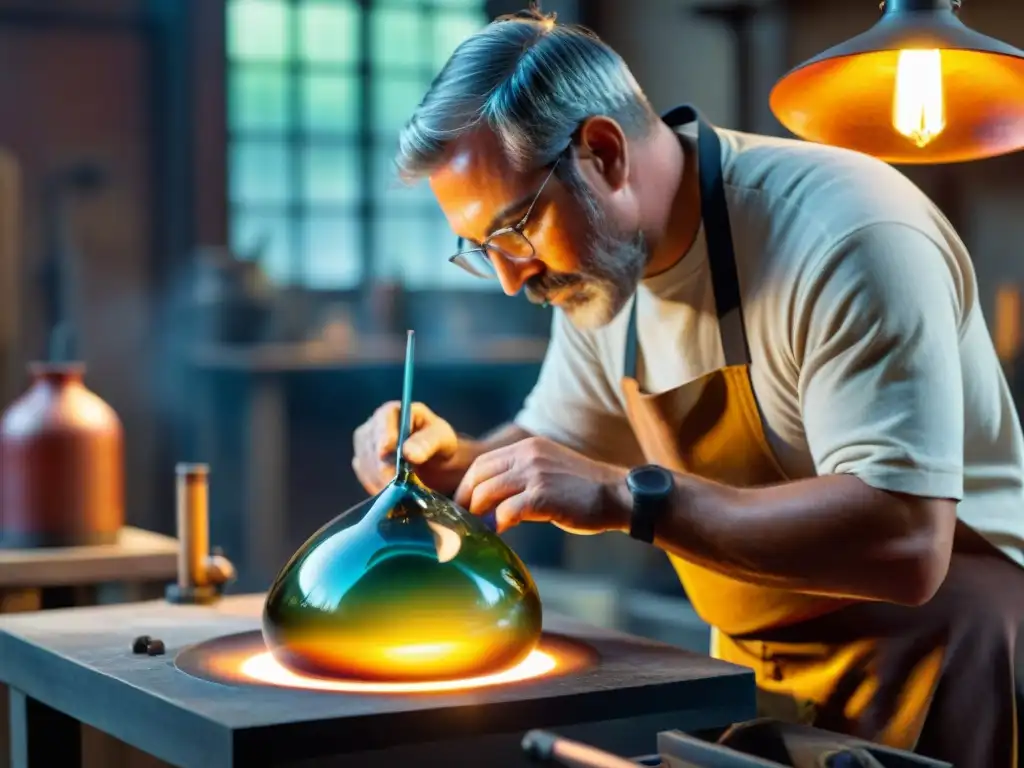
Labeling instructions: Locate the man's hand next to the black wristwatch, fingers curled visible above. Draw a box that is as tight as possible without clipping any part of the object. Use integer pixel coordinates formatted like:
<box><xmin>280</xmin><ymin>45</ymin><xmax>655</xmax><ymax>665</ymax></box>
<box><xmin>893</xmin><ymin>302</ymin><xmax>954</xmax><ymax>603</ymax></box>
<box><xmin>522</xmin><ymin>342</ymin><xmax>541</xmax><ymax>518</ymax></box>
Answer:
<box><xmin>455</xmin><ymin>437</ymin><xmax>632</xmax><ymax>534</ymax></box>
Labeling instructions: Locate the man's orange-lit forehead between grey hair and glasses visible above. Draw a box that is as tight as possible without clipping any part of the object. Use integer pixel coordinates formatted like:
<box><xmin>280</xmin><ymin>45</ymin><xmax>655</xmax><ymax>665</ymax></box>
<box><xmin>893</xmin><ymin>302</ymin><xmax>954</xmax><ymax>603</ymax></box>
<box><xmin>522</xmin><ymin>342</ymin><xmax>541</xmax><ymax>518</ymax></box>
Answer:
<box><xmin>430</xmin><ymin>130</ymin><xmax>528</xmax><ymax>240</ymax></box>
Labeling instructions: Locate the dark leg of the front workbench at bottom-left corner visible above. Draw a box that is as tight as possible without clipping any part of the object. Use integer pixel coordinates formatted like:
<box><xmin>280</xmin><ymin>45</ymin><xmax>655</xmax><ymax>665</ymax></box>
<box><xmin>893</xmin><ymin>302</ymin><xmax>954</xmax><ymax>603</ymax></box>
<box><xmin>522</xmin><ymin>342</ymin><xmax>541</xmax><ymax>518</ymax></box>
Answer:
<box><xmin>7</xmin><ymin>688</ymin><xmax>82</xmax><ymax>768</ymax></box>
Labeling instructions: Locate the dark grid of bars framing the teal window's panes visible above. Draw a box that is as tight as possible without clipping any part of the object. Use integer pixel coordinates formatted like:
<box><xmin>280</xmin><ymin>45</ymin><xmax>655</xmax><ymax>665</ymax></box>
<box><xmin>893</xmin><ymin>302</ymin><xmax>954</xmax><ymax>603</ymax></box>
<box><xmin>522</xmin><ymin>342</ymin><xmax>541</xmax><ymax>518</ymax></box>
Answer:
<box><xmin>224</xmin><ymin>0</ymin><xmax>494</xmax><ymax>294</ymax></box>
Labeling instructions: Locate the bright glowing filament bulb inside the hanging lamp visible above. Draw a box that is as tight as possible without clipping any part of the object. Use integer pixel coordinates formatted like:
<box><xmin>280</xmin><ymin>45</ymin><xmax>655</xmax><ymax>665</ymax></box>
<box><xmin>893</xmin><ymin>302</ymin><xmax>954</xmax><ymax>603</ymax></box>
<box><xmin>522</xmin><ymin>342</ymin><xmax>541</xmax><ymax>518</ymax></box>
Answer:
<box><xmin>893</xmin><ymin>50</ymin><xmax>946</xmax><ymax>148</ymax></box>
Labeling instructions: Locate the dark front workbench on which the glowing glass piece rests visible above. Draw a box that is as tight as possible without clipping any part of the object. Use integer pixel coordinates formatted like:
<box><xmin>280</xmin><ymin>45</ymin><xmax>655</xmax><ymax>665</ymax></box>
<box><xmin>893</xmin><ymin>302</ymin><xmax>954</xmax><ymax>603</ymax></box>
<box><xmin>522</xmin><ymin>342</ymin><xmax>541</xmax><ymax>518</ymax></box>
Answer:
<box><xmin>0</xmin><ymin>595</ymin><xmax>756</xmax><ymax>768</ymax></box>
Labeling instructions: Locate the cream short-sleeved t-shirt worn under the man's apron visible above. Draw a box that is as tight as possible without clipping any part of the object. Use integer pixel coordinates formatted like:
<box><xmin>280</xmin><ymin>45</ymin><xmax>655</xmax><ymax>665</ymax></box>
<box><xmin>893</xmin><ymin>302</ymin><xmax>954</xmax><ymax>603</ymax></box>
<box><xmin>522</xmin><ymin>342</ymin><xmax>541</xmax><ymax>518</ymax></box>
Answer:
<box><xmin>516</xmin><ymin>125</ymin><xmax>1024</xmax><ymax>551</ymax></box>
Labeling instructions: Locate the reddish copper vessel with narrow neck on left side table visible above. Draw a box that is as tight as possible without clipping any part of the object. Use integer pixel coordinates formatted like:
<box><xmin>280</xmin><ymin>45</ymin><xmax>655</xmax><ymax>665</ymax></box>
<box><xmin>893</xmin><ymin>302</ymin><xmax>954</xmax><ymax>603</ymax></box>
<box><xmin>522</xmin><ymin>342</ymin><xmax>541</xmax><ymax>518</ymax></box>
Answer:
<box><xmin>0</xmin><ymin>362</ymin><xmax>124</xmax><ymax>548</ymax></box>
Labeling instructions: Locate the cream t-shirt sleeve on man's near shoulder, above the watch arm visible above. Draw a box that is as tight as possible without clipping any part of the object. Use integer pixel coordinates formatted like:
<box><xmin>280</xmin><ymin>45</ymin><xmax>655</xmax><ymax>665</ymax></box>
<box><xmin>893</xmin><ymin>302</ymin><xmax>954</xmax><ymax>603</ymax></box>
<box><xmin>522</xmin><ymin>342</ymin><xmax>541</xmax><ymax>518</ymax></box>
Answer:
<box><xmin>794</xmin><ymin>219</ymin><xmax>964</xmax><ymax>501</ymax></box>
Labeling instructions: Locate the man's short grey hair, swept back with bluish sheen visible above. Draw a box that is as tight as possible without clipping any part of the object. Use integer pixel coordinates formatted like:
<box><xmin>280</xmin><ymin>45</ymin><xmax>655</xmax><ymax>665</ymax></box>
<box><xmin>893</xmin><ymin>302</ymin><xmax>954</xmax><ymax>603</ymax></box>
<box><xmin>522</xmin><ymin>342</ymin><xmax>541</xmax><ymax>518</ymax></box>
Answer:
<box><xmin>395</xmin><ymin>9</ymin><xmax>657</xmax><ymax>181</ymax></box>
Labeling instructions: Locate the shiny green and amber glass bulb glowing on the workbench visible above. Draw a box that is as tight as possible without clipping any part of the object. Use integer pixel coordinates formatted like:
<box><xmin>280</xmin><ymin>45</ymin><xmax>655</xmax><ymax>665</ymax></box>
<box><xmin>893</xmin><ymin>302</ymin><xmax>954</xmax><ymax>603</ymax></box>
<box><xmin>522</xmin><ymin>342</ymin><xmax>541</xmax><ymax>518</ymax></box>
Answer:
<box><xmin>263</xmin><ymin>469</ymin><xmax>541</xmax><ymax>682</ymax></box>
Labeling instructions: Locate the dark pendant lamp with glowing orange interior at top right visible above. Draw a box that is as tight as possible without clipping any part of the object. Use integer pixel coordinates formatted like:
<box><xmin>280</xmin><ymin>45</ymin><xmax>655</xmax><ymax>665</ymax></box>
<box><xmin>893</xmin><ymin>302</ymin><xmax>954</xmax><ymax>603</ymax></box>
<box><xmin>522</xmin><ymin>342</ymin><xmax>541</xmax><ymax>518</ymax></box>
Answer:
<box><xmin>770</xmin><ymin>0</ymin><xmax>1024</xmax><ymax>164</ymax></box>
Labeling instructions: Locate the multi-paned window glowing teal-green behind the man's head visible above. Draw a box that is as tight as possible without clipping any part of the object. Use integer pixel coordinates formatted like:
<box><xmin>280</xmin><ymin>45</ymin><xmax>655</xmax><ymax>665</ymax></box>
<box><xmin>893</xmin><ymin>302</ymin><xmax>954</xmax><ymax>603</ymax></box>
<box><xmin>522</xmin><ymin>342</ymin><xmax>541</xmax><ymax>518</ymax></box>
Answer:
<box><xmin>227</xmin><ymin>0</ymin><xmax>496</xmax><ymax>290</ymax></box>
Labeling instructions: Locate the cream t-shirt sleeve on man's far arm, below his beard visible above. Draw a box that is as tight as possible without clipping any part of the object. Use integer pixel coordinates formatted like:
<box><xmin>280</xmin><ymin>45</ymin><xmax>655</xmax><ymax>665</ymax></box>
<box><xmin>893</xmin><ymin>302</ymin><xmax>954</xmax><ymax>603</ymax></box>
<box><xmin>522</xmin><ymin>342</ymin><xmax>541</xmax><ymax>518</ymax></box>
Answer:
<box><xmin>515</xmin><ymin>309</ymin><xmax>641</xmax><ymax>466</ymax></box>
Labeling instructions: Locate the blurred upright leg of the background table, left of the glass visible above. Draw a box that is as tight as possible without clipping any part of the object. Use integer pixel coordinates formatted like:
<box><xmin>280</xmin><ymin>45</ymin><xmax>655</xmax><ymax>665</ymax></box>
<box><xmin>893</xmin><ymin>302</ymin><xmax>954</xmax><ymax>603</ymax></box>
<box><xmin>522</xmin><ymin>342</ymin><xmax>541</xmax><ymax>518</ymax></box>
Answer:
<box><xmin>243</xmin><ymin>376</ymin><xmax>291</xmax><ymax>590</ymax></box>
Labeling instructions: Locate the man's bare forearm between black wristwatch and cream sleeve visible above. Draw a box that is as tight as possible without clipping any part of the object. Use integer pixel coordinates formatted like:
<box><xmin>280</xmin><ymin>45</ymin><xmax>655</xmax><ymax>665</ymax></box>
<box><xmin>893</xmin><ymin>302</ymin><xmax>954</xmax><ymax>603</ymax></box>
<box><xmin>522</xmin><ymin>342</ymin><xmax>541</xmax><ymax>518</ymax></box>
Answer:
<box><xmin>655</xmin><ymin>475</ymin><xmax>956</xmax><ymax>604</ymax></box>
